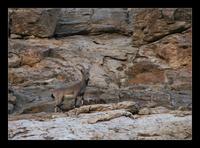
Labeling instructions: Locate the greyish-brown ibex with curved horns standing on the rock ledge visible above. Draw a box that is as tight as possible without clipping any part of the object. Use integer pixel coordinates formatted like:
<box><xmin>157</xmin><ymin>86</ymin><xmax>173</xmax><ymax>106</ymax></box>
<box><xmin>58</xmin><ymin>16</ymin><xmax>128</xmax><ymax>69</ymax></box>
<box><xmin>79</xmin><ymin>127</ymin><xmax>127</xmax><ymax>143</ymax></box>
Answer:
<box><xmin>51</xmin><ymin>64</ymin><xmax>90</xmax><ymax>112</ymax></box>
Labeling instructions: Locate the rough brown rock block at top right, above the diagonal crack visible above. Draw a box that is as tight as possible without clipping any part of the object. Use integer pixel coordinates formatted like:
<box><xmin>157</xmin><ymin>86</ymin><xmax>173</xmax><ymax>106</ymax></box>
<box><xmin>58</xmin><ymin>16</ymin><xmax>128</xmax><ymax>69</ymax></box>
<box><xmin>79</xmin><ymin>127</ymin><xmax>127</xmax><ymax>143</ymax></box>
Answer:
<box><xmin>133</xmin><ymin>8</ymin><xmax>191</xmax><ymax>46</ymax></box>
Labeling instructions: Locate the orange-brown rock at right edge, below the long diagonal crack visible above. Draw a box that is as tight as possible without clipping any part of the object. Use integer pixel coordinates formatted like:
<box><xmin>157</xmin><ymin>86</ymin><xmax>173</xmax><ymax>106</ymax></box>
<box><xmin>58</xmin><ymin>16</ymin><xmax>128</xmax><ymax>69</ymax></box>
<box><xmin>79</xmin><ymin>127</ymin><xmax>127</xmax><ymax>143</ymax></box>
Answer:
<box><xmin>136</xmin><ymin>28</ymin><xmax>192</xmax><ymax>69</ymax></box>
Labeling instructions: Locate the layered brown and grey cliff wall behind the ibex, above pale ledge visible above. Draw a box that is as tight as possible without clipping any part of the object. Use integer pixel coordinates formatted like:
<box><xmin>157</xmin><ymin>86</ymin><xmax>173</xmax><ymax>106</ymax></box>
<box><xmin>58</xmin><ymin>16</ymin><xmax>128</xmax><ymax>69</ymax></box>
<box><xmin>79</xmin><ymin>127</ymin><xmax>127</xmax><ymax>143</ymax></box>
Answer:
<box><xmin>8</xmin><ymin>8</ymin><xmax>192</xmax><ymax>139</ymax></box>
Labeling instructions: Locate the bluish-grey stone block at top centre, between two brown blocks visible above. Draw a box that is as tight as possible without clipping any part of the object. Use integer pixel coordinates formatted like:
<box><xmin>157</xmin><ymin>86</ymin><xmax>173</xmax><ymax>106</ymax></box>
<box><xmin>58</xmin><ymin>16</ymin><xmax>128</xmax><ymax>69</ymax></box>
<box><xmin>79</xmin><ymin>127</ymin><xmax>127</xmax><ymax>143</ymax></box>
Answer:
<box><xmin>55</xmin><ymin>8</ymin><xmax>132</xmax><ymax>37</ymax></box>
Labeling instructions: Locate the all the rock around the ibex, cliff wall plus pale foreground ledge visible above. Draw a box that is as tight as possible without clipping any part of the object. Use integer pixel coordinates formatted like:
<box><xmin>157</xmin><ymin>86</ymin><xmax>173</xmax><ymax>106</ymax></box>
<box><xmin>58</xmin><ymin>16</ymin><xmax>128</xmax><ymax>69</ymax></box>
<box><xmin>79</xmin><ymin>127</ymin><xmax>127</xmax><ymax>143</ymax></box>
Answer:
<box><xmin>8</xmin><ymin>8</ymin><xmax>192</xmax><ymax>140</ymax></box>
